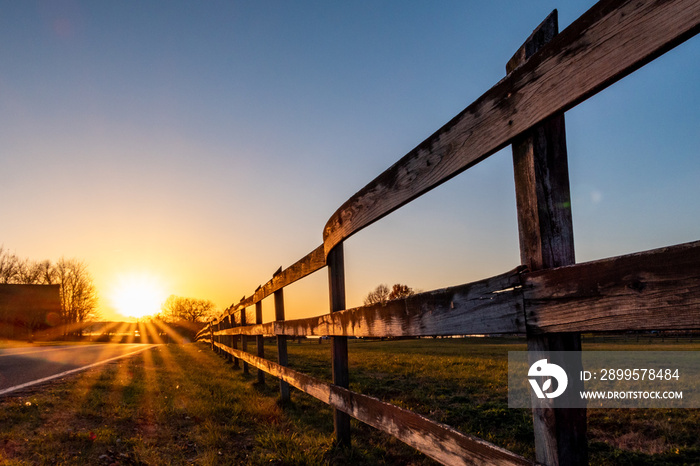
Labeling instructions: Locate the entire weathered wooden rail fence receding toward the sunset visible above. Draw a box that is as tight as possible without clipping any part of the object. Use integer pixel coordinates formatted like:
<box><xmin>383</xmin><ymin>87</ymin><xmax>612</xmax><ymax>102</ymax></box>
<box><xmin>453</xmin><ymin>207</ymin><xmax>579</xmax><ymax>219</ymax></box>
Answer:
<box><xmin>198</xmin><ymin>0</ymin><xmax>700</xmax><ymax>464</ymax></box>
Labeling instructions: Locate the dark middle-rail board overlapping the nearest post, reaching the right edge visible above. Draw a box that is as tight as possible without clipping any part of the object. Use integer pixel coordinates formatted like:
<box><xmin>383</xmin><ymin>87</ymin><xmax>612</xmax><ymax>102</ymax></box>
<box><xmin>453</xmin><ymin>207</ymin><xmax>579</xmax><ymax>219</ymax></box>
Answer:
<box><xmin>523</xmin><ymin>241</ymin><xmax>700</xmax><ymax>333</ymax></box>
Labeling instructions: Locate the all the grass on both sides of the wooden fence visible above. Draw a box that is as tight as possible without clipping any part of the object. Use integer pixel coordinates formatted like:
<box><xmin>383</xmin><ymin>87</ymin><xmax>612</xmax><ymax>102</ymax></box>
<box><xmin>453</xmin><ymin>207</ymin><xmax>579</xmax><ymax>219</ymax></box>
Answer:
<box><xmin>0</xmin><ymin>339</ymin><xmax>700</xmax><ymax>465</ymax></box>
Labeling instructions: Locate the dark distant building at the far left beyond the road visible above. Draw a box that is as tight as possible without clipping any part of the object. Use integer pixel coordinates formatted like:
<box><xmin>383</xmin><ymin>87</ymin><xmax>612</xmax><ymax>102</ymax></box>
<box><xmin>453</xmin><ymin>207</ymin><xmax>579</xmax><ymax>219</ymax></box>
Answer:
<box><xmin>0</xmin><ymin>284</ymin><xmax>61</xmax><ymax>340</ymax></box>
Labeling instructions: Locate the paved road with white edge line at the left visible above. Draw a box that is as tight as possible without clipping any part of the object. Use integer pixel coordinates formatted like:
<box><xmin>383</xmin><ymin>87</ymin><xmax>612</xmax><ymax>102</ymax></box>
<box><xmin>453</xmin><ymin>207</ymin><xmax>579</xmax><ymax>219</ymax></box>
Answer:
<box><xmin>0</xmin><ymin>344</ymin><xmax>156</xmax><ymax>396</ymax></box>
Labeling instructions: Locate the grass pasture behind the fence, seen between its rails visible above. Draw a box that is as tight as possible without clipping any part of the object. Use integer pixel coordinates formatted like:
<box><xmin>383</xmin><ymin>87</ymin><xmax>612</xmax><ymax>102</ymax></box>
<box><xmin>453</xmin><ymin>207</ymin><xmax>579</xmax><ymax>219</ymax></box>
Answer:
<box><xmin>280</xmin><ymin>338</ymin><xmax>700</xmax><ymax>465</ymax></box>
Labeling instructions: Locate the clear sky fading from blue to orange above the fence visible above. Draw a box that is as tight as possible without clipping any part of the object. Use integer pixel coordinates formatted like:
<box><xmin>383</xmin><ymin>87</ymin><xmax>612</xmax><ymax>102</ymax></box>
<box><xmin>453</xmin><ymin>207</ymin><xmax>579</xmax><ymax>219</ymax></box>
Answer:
<box><xmin>0</xmin><ymin>0</ymin><xmax>700</xmax><ymax>317</ymax></box>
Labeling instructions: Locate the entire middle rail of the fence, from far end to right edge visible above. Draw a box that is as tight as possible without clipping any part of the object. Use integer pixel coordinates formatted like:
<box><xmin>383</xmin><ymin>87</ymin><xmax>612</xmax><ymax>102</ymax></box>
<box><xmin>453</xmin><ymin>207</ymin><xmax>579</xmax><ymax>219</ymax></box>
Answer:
<box><xmin>212</xmin><ymin>241</ymin><xmax>700</xmax><ymax>339</ymax></box>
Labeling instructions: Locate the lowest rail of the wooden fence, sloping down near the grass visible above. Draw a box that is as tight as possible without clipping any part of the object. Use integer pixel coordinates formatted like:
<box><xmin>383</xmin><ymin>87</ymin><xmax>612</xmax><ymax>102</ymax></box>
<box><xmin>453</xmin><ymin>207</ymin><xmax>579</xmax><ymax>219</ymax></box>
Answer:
<box><xmin>213</xmin><ymin>345</ymin><xmax>532</xmax><ymax>465</ymax></box>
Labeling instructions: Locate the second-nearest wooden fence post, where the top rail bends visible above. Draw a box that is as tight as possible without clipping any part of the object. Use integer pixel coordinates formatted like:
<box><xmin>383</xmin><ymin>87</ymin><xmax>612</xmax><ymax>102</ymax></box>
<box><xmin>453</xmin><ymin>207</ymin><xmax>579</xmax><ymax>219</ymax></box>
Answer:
<box><xmin>326</xmin><ymin>242</ymin><xmax>350</xmax><ymax>446</ymax></box>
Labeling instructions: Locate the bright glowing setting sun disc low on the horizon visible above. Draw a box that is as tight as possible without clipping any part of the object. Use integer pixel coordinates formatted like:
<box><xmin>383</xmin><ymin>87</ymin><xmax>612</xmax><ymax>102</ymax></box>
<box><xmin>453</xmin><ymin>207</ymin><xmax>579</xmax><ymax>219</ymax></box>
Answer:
<box><xmin>110</xmin><ymin>274</ymin><xmax>168</xmax><ymax>318</ymax></box>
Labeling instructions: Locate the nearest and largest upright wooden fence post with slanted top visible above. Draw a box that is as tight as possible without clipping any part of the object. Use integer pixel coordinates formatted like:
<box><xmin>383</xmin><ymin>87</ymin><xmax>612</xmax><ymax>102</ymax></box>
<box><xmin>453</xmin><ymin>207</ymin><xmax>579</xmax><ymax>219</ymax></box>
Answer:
<box><xmin>506</xmin><ymin>10</ymin><xmax>588</xmax><ymax>465</ymax></box>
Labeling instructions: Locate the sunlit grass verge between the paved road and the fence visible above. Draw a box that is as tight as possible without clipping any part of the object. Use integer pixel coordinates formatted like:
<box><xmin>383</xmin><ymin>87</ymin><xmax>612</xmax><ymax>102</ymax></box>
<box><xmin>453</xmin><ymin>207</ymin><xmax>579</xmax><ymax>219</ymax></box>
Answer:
<box><xmin>0</xmin><ymin>344</ymin><xmax>432</xmax><ymax>465</ymax></box>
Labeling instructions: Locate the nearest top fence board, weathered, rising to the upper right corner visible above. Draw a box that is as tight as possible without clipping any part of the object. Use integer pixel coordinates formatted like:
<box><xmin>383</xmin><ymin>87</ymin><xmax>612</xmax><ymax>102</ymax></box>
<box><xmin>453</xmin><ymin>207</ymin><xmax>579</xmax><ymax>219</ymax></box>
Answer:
<box><xmin>323</xmin><ymin>0</ymin><xmax>700</xmax><ymax>255</ymax></box>
